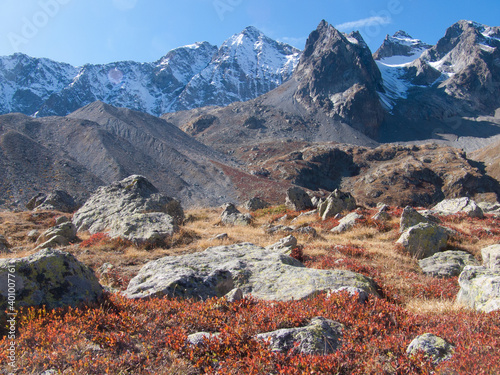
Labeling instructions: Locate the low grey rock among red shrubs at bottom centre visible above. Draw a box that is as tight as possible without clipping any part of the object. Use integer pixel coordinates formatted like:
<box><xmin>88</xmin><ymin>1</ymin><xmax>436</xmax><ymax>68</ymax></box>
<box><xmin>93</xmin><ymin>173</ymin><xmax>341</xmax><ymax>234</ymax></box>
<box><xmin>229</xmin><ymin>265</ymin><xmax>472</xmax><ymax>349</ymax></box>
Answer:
<box><xmin>255</xmin><ymin>317</ymin><xmax>344</xmax><ymax>355</ymax></box>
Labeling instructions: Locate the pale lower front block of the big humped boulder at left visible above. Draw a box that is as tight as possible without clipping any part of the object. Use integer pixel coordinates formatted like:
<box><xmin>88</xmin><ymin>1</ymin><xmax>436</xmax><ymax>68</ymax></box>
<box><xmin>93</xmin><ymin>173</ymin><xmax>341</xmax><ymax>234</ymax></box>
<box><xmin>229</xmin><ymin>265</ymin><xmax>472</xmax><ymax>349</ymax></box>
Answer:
<box><xmin>108</xmin><ymin>212</ymin><xmax>178</xmax><ymax>245</ymax></box>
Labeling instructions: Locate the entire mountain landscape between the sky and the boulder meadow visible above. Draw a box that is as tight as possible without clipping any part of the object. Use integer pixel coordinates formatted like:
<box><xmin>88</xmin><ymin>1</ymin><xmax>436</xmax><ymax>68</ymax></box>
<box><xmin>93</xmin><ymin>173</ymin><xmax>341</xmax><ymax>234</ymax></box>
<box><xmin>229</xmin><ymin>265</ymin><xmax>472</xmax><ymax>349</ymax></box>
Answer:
<box><xmin>0</xmin><ymin>21</ymin><xmax>500</xmax><ymax>208</ymax></box>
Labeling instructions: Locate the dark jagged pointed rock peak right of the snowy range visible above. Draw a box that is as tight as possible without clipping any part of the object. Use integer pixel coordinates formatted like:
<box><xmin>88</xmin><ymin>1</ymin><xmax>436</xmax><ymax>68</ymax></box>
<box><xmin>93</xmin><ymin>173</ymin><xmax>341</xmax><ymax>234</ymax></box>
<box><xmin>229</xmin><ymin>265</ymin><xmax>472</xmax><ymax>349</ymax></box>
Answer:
<box><xmin>294</xmin><ymin>21</ymin><xmax>384</xmax><ymax>135</ymax></box>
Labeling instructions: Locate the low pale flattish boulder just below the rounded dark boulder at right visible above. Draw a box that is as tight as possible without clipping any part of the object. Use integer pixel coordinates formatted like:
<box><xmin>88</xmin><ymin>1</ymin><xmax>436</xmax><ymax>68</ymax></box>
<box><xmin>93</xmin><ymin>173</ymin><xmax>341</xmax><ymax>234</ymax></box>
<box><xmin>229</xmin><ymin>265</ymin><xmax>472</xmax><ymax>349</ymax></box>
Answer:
<box><xmin>418</xmin><ymin>250</ymin><xmax>479</xmax><ymax>278</ymax></box>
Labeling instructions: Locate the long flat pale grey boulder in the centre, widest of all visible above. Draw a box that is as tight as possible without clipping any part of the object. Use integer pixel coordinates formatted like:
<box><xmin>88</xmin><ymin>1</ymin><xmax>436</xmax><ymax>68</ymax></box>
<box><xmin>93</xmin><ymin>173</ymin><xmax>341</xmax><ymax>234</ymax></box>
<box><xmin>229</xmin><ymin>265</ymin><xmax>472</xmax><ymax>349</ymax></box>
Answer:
<box><xmin>125</xmin><ymin>243</ymin><xmax>377</xmax><ymax>301</ymax></box>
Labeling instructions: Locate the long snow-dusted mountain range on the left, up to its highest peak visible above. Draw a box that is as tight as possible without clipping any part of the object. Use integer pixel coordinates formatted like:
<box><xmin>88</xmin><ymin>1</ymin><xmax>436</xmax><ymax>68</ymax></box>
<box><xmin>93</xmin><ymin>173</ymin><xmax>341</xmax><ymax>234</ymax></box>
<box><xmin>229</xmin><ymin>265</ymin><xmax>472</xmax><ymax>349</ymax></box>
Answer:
<box><xmin>0</xmin><ymin>27</ymin><xmax>300</xmax><ymax>116</ymax></box>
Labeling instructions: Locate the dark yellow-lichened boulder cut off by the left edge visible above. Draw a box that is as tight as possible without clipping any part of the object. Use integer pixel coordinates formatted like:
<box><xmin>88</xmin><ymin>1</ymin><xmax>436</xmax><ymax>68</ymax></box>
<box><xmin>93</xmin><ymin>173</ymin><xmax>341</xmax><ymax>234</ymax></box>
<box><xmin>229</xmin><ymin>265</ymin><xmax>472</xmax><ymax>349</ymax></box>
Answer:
<box><xmin>0</xmin><ymin>249</ymin><xmax>103</xmax><ymax>311</ymax></box>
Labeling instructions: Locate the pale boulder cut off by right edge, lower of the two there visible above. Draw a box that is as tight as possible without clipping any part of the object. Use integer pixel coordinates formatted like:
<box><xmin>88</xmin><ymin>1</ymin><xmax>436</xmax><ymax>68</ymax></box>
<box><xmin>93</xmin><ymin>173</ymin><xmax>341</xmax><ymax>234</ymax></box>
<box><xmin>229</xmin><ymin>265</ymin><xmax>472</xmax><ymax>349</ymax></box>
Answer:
<box><xmin>456</xmin><ymin>266</ymin><xmax>500</xmax><ymax>312</ymax></box>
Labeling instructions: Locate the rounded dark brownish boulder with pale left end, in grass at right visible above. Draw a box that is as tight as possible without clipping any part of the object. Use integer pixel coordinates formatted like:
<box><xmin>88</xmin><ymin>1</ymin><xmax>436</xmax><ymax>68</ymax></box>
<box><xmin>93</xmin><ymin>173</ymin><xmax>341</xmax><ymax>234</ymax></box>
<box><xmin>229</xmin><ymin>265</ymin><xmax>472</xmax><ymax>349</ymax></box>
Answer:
<box><xmin>397</xmin><ymin>223</ymin><xmax>448</xmax><ymax>259</ymax></box>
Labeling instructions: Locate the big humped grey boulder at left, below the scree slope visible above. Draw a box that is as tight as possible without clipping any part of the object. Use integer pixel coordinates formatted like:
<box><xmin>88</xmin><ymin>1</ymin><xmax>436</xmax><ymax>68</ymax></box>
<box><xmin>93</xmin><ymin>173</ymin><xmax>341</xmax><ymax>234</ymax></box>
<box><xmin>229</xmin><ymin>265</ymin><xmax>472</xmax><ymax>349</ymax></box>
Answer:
<box><xmin>73</xmin><ymin>175</ymin><xmax>184</xmax><ymax>242</ymax></box>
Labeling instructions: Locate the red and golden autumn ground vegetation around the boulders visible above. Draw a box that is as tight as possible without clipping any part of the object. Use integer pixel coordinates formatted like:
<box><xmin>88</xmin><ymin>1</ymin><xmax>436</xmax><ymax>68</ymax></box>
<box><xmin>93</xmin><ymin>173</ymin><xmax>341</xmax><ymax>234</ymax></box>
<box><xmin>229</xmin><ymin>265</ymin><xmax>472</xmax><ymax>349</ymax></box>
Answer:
<box><xmin>0</xmin><ymin>206</ymin><xmax>500</xmax><ymax>374</ymax></box>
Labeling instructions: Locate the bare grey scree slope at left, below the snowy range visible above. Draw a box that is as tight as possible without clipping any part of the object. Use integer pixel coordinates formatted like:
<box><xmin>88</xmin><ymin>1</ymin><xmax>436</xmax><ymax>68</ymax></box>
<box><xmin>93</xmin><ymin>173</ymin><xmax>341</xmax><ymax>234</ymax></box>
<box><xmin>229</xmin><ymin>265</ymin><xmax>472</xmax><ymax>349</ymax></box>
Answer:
<box><xmin>0</xmin><ymin>102</ymin><xmax>242</xmax><ymax>206</ymax></box>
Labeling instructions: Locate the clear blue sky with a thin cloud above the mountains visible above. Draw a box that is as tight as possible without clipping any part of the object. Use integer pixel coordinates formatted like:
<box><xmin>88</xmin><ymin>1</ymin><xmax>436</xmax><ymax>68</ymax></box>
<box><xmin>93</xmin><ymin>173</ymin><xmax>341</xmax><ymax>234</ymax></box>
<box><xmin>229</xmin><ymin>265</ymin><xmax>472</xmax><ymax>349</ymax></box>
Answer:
<box><xmin>0</xmin><ymin>0</ymin><xmax>500</xmax><ymax>66</ymax></box>
